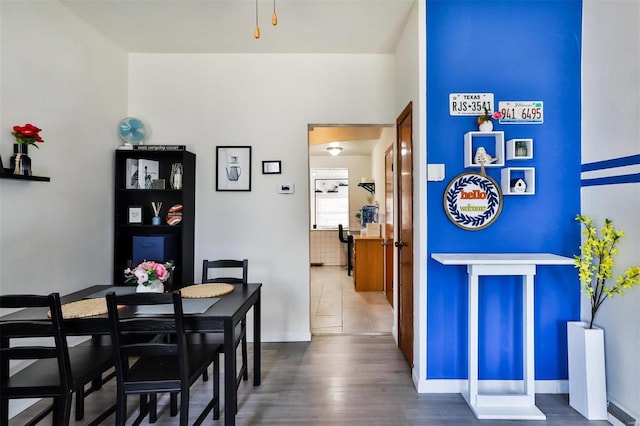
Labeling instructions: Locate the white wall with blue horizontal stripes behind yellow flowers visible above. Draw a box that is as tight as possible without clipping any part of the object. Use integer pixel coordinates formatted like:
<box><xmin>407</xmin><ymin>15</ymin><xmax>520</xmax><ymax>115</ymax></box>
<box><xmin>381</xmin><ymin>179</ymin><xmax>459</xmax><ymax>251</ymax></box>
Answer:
<box><xmin>581</xmin><ymin>0</ymin><xmax>640</xmax><ymax>419</ymax></box>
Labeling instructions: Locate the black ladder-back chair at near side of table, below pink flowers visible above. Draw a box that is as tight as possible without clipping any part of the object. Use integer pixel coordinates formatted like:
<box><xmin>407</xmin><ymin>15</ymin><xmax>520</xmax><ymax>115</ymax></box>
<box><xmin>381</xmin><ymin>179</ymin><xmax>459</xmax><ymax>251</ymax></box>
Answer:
<box><xmin>106</xmin><ymin>291</ymin><xmax>222</xmax><ymax>426</ymax></box>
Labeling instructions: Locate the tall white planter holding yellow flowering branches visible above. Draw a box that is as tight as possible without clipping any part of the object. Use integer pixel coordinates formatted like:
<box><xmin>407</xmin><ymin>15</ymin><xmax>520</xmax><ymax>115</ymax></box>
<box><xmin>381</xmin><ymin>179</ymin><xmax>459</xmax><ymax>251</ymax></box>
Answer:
<box><xmin>567</xmin><ymin>321</ymin><xmax>607</xmax><ymax>420</ymax></box>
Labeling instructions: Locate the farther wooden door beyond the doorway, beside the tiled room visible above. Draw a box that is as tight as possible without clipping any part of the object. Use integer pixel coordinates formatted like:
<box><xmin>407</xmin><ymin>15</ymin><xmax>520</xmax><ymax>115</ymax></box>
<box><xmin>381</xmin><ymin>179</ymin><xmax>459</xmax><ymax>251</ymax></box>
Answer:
<box><xmin>382</xmin><ymin>146</ymin><xmax>394</xmax><ymax>306</ymax></box>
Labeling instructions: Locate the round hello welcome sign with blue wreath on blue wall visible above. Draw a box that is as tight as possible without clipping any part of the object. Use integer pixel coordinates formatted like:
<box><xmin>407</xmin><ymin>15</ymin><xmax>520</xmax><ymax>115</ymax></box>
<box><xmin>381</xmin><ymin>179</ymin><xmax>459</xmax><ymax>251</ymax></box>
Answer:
<box><xmin>443</xmin><ymin>172</ymin><xmax>502</xmax><ymax>231</ymax></box>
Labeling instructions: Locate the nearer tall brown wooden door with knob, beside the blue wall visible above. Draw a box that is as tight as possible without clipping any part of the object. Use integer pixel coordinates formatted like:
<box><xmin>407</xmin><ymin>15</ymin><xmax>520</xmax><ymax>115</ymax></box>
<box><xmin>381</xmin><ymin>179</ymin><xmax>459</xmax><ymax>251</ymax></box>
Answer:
<box><xmin>394</xmin><ymin>102</ymin><xmax>413</xmax><ymax>367</ymax></box>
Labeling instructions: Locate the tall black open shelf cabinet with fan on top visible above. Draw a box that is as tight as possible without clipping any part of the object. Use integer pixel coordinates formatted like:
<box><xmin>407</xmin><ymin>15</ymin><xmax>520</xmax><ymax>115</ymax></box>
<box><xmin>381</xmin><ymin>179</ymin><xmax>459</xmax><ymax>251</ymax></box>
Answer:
<box><xmin>113</xmin><ymin>147</ymin><xmax>196</xmax><ymax>289</ymax></box>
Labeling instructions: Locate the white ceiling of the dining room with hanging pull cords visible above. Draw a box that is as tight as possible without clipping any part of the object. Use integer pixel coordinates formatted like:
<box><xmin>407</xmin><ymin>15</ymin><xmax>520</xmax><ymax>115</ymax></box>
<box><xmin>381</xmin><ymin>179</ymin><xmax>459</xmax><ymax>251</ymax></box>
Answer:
<box><xmin>60</xmin><ymin>0</ymin><xmax>417</xmax><ymax>54</ymax></box>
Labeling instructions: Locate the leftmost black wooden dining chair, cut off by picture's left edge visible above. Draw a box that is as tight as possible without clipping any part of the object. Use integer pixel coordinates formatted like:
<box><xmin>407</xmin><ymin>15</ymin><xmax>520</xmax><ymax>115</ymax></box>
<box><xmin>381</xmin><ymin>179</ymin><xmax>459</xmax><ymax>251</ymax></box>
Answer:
<box><xmin>0</xmin><ymin>293</ymin><xmax>114</xmax><ymax>425</ymax></box>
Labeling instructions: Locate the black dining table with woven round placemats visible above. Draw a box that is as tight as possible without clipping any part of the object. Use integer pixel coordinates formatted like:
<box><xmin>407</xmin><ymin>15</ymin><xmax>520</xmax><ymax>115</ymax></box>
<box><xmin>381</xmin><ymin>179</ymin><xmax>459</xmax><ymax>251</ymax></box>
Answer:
<box><xmin>0</xmin><ymin>283</ymin><xmax>262</xmax><ymax>425</ymax></box>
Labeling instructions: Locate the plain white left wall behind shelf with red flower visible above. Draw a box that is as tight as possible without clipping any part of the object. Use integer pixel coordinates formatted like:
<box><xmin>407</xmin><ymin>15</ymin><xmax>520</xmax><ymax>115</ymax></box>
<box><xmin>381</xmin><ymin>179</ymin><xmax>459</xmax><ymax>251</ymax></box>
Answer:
<box><xmin>0</xmin><ymin>1</ymin><xmax>127</xmax><ymax>294</ymax></box>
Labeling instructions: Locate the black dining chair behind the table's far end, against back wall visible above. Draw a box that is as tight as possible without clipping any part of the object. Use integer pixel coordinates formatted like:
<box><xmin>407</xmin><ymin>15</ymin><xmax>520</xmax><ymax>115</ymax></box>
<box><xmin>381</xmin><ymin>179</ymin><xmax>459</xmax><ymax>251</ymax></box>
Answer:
<box><xmin>202</xmin><ymin>259</ymin><xmax>249</xmax><ymax>410</ymax></box>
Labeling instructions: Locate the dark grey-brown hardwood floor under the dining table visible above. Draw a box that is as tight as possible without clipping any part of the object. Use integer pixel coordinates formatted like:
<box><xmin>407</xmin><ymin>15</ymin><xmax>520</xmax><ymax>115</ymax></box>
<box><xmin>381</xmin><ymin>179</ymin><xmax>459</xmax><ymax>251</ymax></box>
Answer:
<box><xmin>9</xmin><ymin>335</ymin><xmax>608</xmax><ymax>426</ymax></box>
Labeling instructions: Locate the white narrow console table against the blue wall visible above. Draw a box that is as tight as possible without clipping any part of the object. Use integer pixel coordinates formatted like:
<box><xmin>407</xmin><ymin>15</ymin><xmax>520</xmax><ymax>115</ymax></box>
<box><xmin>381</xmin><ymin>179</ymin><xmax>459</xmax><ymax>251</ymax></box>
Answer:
<box><xmin>431</xmin><ymin>253</ymin><xmax>573</xmax><ymax>420</ymax></box>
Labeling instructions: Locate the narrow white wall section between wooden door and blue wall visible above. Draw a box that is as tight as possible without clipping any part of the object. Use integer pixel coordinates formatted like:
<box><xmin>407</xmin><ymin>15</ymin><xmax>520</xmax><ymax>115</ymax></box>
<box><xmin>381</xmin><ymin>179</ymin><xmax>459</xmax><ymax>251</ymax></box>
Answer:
<box><xmin>394</xmin><ymin>0</ymin><xmax>427</xmax><ymax>392</ymax></box>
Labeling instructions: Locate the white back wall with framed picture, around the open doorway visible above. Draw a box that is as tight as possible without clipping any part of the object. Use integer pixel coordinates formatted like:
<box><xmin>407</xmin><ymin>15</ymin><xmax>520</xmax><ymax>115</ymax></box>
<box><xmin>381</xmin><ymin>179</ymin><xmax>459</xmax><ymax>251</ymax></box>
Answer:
<box><xmin>129</xmin><ymin>54</ymin><xmax>395</xmax><ymax>341</ymax></box>
